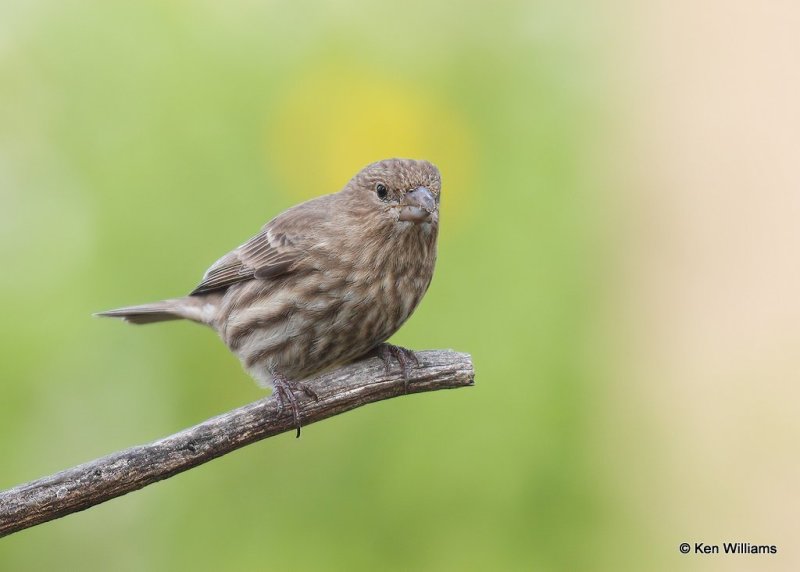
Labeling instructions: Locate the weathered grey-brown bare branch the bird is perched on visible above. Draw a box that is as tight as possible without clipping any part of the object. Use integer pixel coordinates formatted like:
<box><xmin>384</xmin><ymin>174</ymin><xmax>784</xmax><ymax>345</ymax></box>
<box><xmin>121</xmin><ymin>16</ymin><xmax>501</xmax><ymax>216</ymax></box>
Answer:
<box><xmin>0</xmin><ymin>350</ymin><xmax>475</xmax><ymax>537</ymax></box>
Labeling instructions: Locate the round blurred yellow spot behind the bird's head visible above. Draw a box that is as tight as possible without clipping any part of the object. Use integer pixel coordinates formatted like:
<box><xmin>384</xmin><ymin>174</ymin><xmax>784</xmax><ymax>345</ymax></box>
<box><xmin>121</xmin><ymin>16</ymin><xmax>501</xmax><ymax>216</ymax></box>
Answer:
<box><xmin>267</xmin><ymin>68</ymin><xmax>475</xmax><ymax>226</ymax></box>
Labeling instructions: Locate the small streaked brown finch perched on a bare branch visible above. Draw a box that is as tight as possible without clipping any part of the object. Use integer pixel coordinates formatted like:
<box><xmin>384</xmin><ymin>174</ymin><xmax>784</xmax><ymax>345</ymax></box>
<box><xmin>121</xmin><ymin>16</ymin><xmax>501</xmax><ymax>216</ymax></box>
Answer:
<box><xmin>98</xmin><ymin>159</ymin><xmax>441</xmax><ymax>436</ymax></box>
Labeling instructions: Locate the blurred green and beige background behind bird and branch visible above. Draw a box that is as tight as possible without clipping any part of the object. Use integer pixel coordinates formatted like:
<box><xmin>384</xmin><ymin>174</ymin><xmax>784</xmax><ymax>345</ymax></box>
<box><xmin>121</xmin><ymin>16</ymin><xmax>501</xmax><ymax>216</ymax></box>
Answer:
<box><xmin>0</xmin><ymin>0</ymin><xmax>800</xmax><ymax>571</ymax></box>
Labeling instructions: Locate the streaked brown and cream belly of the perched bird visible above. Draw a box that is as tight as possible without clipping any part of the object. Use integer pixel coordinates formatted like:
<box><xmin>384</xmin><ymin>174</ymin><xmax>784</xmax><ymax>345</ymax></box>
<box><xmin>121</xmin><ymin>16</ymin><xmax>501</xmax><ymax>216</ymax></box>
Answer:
<box><xmin>221</xmin><ymin>273</ymin><xmax>429</xmax><ymax>381</ymax></box>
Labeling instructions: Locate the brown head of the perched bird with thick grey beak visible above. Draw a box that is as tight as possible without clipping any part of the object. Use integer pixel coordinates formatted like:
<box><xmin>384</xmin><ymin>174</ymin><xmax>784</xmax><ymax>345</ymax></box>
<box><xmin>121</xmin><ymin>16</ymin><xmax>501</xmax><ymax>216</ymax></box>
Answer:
<box><xmin>344</xmin><ymin>159</ymin><xmax>442</xmax><ymax>231</ymax></box>
